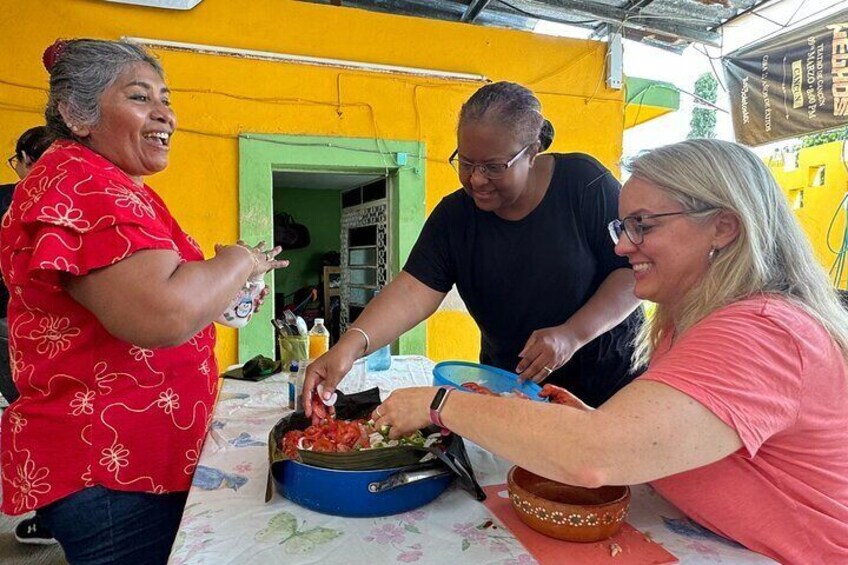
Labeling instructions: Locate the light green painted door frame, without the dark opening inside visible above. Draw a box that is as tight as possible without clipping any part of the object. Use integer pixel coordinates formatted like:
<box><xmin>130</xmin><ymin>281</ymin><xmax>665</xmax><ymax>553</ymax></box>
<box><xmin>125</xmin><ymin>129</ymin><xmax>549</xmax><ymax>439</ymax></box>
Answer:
<box><xmin>238</xmin><ymin>134</ymin><xmax>427</xmax><ymax>363</ymax></box>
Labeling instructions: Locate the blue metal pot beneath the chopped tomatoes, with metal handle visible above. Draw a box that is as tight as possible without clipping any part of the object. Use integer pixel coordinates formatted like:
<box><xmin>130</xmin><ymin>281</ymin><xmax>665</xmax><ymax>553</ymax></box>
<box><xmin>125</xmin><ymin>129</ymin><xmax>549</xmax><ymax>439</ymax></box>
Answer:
<box><xmin>271</xmin><ymin>459</ymin><xmax>455</xmax><ymax>518</ymax></box>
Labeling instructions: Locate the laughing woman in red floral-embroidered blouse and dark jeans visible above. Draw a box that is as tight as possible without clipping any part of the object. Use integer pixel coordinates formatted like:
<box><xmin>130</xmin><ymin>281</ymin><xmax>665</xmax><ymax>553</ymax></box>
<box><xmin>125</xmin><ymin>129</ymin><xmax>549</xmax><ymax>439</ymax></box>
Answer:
<box><xmin>0</xmin><ymin>39</ymin><xmax>287</xmax><ymax>564</ymax></box>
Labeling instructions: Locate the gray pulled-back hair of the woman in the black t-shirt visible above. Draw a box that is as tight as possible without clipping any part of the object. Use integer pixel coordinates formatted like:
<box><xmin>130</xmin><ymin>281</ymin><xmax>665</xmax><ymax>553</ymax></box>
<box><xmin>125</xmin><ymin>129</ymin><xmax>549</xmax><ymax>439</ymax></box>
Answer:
<box><xmin>459</xmin><ymin>81</ymin><xmax>554</xmax><ymax>151</ymax></box>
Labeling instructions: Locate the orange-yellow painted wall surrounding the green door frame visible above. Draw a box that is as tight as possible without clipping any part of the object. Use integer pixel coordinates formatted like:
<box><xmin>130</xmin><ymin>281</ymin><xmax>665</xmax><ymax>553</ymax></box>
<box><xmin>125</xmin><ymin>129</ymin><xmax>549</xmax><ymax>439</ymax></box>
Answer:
<box><xmin>0</xmin><ymin>0</ymin><xmax>624</xmax><ymax>364</ymax></box>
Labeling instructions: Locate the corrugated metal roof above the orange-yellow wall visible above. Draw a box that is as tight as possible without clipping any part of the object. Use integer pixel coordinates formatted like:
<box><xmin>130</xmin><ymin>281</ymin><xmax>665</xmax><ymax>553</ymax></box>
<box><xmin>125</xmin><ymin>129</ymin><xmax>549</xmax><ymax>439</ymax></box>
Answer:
<box><xmin>302</xmin><ymin>0</ymin><xmax>771</xmax><ymax>51</ymax></box>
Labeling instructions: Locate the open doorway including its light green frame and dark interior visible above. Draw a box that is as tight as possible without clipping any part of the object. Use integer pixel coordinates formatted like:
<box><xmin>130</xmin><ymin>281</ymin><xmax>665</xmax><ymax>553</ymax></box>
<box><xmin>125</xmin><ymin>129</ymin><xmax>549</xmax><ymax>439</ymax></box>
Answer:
<box><xmin>238</xmin><ymin>134</ymin><xmax>426</xmax><ymax>362</ymax></box>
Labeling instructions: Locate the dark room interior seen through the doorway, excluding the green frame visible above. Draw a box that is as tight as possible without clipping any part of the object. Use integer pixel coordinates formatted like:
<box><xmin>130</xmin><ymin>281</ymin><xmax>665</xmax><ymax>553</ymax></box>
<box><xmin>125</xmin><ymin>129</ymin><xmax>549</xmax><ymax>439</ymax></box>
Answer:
<box><xmin>272</xmin><ymin>171</ymin><xmax>394</xmax><ymax>344</ymax></box>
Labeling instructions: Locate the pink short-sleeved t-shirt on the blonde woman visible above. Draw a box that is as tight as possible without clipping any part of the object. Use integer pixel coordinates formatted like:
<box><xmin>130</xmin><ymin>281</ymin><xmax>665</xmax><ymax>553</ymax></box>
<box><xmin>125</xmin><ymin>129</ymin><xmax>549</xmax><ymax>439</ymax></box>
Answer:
<box><xmin>640</xmin><ymin>298</ymin><xmax>848</xmax><ymax>563</ymax></box>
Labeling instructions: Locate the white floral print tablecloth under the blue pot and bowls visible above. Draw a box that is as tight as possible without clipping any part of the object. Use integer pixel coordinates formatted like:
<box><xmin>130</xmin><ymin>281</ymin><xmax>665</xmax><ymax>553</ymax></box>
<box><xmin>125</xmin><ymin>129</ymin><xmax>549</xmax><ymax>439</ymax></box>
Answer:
<box><xmin>169</xmin><ymin>356</ymin><xmax>771</xmax><ymax>565</ymax></box>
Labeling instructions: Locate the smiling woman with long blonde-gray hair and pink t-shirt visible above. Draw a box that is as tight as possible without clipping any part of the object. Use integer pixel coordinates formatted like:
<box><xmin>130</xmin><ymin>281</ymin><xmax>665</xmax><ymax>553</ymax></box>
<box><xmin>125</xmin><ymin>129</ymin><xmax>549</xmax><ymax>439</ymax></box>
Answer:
<box><xmin>375</xmin><ymin>140</ymin><xmax>848</xmax><ymax>564</ymax></box>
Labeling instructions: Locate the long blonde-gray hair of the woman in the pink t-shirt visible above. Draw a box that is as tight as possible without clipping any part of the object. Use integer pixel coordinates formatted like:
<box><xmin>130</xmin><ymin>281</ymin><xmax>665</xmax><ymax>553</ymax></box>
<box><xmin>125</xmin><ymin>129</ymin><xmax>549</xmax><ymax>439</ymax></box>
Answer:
<box><xmin>628</xmin><ymin>139</ymin><xmax>848</xmax><ymax>367</ymax></box>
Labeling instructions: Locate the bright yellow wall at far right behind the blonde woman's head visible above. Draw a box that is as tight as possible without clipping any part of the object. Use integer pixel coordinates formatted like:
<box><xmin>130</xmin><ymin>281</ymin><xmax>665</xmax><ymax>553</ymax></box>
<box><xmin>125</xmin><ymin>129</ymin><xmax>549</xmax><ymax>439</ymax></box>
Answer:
<box><xmin>765</xmin><ymin>141</ymin><xmax>848</xmax><ymax>289</ymax></box>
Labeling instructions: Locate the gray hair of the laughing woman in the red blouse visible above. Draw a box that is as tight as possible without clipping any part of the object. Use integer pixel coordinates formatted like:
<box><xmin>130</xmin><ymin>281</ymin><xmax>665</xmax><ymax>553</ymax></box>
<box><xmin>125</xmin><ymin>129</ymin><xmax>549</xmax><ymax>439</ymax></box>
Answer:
<box><xmin>44</xmin><ymin>39</ymin><xmax>164</xmax><ymax>139</ymax></box>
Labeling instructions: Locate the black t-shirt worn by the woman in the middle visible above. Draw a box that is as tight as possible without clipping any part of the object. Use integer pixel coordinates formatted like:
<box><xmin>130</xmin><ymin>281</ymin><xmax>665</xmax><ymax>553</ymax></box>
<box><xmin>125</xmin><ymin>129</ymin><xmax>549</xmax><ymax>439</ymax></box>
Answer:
<box><xmin>404</xmin><ymin>153</ymin><xmax>640</xmax><ymax>406</ymax></box>
